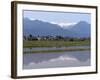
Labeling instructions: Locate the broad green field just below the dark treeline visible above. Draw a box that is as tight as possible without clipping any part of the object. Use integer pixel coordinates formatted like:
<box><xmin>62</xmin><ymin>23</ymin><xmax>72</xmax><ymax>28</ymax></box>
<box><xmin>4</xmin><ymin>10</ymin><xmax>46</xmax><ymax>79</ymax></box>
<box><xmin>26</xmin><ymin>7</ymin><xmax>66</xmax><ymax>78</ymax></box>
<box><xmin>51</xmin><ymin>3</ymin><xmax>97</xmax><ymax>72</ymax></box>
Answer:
<box><xmin>23</xmin><ymin>40</ymin><xmax>90</xmax><ymax>48</ymax></box>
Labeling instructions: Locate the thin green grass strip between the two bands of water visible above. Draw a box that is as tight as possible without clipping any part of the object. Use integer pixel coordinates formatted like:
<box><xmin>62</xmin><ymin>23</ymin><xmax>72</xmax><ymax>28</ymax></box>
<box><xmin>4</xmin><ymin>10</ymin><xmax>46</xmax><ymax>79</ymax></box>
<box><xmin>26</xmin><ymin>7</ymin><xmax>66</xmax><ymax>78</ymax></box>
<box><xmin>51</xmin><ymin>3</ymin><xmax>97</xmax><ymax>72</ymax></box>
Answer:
<box><xmin>24</xmin><ymin>48</ymin><xmax>90</xmax><ymax>53</ymax></box>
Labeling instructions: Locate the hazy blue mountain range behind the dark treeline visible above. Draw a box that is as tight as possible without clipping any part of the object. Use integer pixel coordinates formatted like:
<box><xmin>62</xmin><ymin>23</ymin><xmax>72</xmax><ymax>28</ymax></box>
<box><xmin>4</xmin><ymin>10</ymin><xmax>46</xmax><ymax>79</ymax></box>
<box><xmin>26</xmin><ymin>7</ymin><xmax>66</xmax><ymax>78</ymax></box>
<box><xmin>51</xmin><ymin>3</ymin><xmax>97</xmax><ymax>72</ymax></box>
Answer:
<box><xmin>23</xmin><ymin>18</ymin><xmax>91</xmax><ymax>37</ymax></box>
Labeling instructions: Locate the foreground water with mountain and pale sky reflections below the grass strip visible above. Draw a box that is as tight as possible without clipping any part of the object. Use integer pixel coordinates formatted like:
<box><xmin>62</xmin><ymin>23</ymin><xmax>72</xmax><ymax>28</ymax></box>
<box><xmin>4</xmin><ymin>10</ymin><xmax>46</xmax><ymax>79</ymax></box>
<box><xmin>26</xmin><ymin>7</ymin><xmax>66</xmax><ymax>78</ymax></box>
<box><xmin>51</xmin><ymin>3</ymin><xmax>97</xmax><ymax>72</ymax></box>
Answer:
<box><xmin>23</xmin><ymin>51</ymin><xmax>91</xmax><ymax>69</ymax></box>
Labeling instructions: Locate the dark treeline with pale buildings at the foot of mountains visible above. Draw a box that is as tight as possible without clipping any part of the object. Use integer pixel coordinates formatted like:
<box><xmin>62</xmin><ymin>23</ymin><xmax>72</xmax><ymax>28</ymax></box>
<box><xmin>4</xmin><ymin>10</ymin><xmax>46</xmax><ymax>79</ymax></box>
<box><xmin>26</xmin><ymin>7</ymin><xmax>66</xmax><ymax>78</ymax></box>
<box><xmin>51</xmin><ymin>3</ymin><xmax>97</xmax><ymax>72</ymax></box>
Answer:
<box><xmin>23</xmin><ymin>34</ymin><xmax>90</xmax><ymax>41</ymax></box>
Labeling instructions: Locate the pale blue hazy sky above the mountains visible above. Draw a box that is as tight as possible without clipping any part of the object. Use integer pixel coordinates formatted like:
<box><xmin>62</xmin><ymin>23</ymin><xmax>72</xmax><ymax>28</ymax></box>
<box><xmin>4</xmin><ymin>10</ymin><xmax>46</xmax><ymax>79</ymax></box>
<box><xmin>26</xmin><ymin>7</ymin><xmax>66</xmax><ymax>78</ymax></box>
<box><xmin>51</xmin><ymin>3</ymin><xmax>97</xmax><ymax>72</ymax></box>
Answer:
<box><xmin>23</xmin><ymin>10</ymin><xmax>91</xmax><ymax>23</ymax></box>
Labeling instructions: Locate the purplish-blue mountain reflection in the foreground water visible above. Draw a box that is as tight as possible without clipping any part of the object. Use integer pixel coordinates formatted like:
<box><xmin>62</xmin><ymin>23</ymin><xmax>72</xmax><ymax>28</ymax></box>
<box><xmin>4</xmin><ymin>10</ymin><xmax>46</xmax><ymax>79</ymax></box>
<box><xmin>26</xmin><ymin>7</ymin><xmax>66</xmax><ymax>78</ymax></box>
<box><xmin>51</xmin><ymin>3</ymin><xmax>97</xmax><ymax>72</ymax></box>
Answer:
<box><xmin>24</xmin><ymin>51</ymin><xmax>90</xmax><ymax>64</ymax></box>
